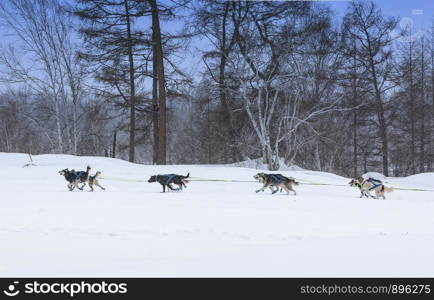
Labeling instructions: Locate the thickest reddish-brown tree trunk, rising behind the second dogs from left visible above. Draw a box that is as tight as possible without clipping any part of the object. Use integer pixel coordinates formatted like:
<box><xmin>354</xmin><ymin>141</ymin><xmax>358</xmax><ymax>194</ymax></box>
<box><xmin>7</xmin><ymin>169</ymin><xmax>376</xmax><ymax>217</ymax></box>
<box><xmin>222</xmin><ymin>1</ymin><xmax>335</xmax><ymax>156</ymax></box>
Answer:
<box><xmin>149</xmin><ymin>0</ymin><xmax>167</xmax><ymax>165</ymax></box>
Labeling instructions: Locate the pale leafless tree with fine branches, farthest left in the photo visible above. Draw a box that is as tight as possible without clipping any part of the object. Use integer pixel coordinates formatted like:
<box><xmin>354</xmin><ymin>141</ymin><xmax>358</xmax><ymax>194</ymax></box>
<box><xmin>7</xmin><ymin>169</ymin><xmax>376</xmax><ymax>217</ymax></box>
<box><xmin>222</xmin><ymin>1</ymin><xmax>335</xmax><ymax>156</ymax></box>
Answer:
<box><xmin>0</xmin><ymin>0</ymin><xmax>83</xmax><ymax>153</ymax></box>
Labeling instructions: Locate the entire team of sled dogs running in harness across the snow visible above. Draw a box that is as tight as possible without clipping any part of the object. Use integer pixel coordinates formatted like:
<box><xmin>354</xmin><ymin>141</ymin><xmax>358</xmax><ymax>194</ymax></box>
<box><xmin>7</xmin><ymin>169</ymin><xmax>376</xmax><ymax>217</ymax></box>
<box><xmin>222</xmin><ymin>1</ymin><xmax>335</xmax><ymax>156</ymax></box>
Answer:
<box><xmin>59</xmin><ymin>166</ymin><xmax>393</xmax><ymax>199</ymax></box>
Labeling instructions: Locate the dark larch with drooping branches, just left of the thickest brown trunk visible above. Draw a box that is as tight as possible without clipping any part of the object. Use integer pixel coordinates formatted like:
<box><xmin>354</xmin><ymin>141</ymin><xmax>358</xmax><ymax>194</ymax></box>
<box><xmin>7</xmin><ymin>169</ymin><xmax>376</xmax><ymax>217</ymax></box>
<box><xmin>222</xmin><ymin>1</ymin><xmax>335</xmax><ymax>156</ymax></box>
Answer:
<box><xmin>74</xmin><ymin>0</ymin><xmax>150</xmax><ymax>162</ymax></box>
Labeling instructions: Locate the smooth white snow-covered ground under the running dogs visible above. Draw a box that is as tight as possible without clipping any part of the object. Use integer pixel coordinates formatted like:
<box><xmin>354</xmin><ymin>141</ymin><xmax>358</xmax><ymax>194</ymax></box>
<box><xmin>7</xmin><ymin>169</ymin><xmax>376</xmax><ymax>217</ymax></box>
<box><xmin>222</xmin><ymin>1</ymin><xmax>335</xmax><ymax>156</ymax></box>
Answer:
<box><xmin>0</xmin><ymin>153</ymin><xmax>434</xmax><ymax>277</ymax></box>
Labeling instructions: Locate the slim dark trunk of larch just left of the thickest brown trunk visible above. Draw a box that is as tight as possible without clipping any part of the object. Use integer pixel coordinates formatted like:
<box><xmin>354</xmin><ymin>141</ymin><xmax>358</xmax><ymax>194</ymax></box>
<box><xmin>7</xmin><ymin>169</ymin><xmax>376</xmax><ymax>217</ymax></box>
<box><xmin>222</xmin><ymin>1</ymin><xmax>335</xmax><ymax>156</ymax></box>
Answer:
<box><xmin>124</xmin><ymin>0</ymin><xmax>136</xmax><ymax>162</ymax></box>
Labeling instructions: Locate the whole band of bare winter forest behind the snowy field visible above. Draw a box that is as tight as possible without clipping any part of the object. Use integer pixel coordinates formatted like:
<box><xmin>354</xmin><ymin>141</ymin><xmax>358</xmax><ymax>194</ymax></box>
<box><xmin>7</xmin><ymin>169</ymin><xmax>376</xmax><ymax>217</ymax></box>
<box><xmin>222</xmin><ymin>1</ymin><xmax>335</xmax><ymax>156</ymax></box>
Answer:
<box><xmin>0</xmin><ymin>0</ymin><xmax>434</xmax><ymax>176</ymax></box>
